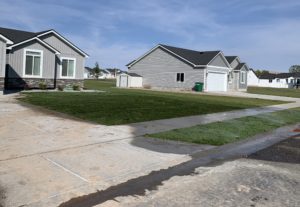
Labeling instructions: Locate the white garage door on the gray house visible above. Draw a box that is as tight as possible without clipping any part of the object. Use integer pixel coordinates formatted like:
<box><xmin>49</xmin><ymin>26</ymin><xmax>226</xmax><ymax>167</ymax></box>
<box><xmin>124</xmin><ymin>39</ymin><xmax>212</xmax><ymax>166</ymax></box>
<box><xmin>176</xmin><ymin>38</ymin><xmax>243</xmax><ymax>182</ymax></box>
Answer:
<box><xmin>207</xmin><ymin>72</ymin><xmax>227</xmax><ymax>91</ymax></box>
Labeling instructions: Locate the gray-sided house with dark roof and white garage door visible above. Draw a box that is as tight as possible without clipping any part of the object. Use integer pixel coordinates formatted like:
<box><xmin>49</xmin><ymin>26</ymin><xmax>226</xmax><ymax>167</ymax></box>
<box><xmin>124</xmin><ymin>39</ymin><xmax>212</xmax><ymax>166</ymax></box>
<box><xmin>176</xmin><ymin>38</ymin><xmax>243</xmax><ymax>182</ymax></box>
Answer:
<box><xmin>127</xmin><ymin>44</ymin><xmax>247</xmax><ymax>91</ymax></box>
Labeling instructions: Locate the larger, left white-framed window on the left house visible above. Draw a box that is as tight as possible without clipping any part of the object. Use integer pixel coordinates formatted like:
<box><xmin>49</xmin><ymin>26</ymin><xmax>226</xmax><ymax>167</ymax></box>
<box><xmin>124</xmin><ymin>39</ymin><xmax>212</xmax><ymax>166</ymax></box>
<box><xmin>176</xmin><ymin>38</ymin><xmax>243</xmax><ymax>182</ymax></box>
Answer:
<box><xmin>24</xmin><ymin>49</ymin><xmax>43</xmax><ymax>77</ymax></box>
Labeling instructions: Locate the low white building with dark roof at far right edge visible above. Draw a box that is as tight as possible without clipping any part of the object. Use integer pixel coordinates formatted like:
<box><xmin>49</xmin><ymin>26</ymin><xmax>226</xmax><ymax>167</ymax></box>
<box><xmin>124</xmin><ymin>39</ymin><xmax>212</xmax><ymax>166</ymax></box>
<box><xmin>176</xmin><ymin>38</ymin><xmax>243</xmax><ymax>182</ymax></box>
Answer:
<box><xmin>258</xmin><ymin>73</ymin><xmax>300</xmax><ymax>88</ymax></box>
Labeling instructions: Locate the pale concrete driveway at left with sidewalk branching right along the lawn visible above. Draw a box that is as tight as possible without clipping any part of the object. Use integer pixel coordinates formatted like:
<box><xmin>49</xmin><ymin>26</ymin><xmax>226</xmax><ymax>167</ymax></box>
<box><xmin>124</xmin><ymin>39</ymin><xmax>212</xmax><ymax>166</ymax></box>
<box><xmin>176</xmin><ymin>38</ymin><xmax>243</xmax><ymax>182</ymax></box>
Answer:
<box><xmin>0</xmin><ymin>95</ymin><xmax>299</xmax><ymax>207</ymax></box>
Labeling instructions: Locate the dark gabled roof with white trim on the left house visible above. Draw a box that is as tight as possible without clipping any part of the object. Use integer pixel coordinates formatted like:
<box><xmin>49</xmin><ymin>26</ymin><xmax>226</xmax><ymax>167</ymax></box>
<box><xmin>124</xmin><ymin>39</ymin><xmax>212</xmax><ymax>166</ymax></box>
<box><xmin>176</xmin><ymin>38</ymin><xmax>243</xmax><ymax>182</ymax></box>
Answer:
<box><xmin>0</xmin><ymin>27</ymin><xmax>88</xmax><ymax>57</ymax></box>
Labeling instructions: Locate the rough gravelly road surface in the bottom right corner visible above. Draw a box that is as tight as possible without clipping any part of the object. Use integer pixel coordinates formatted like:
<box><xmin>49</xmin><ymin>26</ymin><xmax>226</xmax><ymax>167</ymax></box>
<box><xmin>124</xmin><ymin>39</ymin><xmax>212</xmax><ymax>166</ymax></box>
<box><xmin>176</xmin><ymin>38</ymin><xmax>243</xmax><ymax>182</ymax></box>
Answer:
<box><xmin>96</xmin><ymin>135</ymin><xmax>300</xmax><ymax>207</ymax></box>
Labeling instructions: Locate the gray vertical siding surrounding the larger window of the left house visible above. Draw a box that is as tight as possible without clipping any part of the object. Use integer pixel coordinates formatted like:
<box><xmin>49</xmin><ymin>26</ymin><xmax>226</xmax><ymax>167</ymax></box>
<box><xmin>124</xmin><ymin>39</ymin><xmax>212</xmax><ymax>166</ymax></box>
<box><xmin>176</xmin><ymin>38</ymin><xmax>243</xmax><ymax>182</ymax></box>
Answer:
<box><xmin>8</xmin><ymin>40</ymin><xmax>55</xmax><ymax>79</ymax></box>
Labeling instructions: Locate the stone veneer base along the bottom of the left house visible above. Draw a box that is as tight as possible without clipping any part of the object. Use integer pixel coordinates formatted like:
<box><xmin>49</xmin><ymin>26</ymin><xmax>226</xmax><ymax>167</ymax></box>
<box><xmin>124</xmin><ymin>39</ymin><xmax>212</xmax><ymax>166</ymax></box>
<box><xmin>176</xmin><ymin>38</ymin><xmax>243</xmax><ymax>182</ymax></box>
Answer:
<box><xmin>4</xmin><ymin>78</ymin><xmax>83</xmax><ymax>90</ymax></box>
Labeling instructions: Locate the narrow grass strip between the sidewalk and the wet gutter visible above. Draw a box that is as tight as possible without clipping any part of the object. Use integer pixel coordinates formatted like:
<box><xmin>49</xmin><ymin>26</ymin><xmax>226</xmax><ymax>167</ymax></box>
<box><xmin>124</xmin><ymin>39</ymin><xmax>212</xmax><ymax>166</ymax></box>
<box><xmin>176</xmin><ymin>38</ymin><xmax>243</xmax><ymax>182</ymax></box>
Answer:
<box><xmin>147</xmin><ymin>108</ymin><xmax>300</xmax><ymax>145</ymax></box>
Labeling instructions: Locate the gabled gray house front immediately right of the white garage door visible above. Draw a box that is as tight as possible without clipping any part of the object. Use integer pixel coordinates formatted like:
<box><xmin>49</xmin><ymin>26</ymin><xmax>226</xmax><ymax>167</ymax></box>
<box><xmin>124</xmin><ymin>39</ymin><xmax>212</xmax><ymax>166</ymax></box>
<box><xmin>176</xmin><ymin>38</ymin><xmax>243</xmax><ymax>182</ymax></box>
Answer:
<box><xmin>225</xmin><ymin>56</ymin><xmax>249</xmax><ymax>91</ymax></box>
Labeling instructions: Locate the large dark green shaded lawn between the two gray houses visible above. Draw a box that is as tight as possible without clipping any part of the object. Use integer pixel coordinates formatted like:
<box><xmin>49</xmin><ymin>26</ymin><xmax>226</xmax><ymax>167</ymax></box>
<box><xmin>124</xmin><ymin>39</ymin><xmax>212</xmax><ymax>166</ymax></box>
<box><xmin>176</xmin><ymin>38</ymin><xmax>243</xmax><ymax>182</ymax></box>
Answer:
<box><xmin>21</xmin><ymin>80</ymin><xmax>283</xmax><ymax>125</ymax></box>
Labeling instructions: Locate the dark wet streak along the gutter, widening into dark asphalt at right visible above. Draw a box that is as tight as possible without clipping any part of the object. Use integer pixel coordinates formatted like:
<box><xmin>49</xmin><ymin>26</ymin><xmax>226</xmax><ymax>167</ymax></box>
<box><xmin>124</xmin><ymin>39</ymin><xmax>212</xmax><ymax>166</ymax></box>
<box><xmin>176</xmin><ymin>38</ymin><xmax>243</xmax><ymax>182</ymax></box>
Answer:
<box><xmin>60</xmin><ymin>135</ymin><xmax>300</xmax><ymax>207</ymax></box>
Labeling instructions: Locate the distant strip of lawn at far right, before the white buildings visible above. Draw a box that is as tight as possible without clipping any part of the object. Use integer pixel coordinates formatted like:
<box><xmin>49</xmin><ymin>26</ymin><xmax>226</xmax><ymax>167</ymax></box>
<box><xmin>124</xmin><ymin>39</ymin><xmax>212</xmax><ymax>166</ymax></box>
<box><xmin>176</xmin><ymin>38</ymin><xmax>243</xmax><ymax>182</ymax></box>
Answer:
<box><xmin>247</xmin><ymin>87</ymin><xmax>300</xmax><ymax>98</ymax></box>
